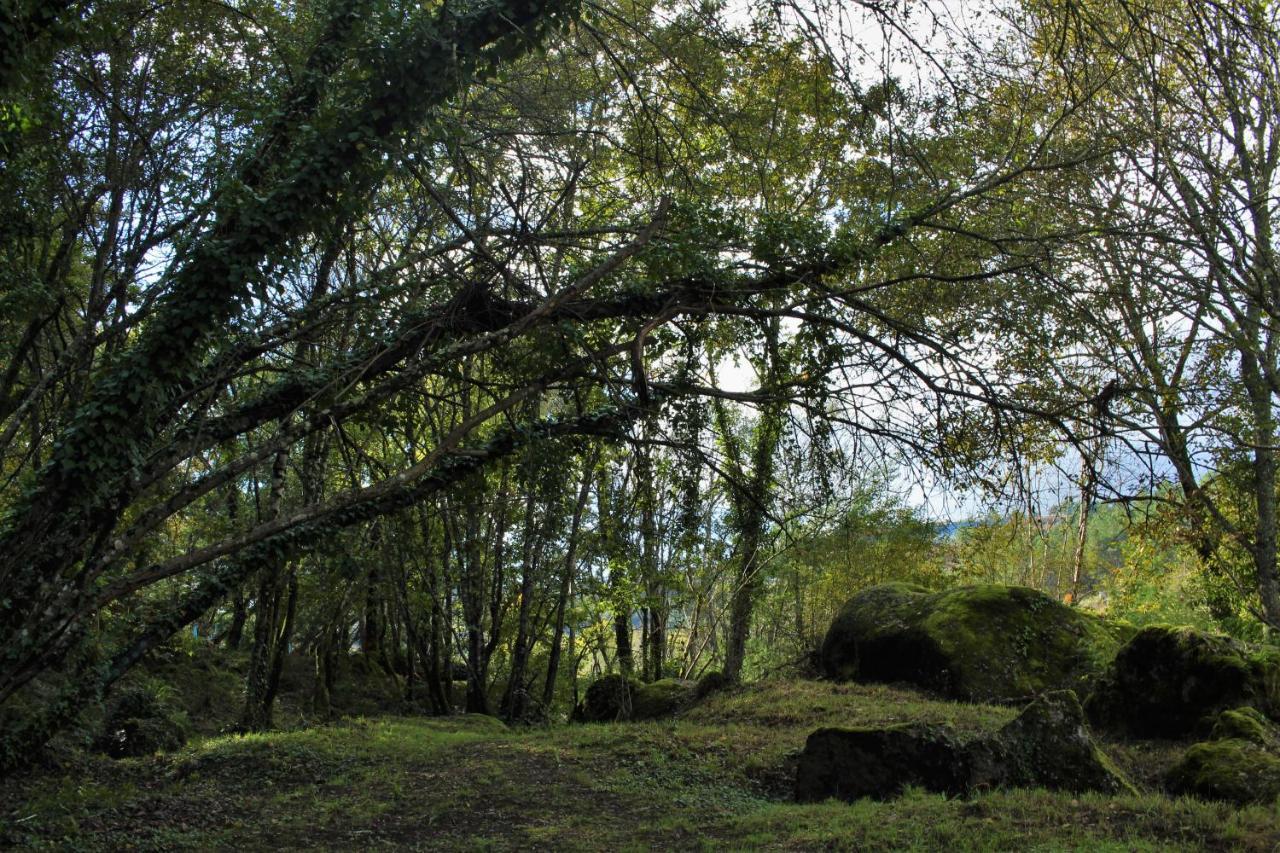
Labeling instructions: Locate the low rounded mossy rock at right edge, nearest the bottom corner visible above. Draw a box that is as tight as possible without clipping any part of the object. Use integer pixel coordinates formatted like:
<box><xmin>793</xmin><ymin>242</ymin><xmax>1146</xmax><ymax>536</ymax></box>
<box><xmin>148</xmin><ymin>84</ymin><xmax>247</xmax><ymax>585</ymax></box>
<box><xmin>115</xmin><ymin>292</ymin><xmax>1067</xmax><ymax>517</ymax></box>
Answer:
<box><xmin>1166</xmin><ymin>738</ymin><xmax>1280</xmax><ymax>804</ymax></box>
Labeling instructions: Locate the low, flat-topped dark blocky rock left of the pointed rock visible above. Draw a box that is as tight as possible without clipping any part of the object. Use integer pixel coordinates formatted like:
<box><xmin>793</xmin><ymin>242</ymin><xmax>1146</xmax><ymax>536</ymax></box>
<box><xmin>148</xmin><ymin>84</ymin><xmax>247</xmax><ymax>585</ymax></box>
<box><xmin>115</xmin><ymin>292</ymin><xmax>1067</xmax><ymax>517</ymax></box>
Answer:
<box><xmin>795</xmin><ymin>724</ymin><xmax>968</xmax><ymax>803</ymax></box>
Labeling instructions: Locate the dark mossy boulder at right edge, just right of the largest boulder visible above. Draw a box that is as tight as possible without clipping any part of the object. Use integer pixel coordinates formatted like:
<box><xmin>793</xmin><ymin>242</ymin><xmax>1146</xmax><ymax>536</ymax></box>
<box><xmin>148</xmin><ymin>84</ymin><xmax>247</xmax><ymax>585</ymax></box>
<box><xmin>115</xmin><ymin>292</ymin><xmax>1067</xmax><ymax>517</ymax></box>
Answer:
<box><xmin>1085</xmin><ymin>626</ymin><xmax>1280</xmax><ymax>738</ymax></box>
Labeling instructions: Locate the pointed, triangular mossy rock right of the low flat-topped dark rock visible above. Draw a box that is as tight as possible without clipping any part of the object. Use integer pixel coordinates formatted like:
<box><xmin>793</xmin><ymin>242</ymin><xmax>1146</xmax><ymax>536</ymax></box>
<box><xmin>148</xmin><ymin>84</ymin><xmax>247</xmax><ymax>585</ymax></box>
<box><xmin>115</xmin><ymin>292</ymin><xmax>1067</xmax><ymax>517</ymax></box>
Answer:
<box><xmin>969</xmin><ymin>690</ymin><xmax>1134</xmax><ymax>794</ymax></box>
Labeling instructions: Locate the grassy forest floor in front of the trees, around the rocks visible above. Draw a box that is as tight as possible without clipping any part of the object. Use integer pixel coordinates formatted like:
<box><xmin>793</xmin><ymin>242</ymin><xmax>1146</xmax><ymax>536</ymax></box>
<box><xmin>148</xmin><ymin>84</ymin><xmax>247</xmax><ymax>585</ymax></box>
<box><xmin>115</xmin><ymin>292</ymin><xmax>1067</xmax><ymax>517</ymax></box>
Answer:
<box><xmin>0</xmin><ymin>680</ymin><xmax>1280</xmax><ymax>850</ymax></box>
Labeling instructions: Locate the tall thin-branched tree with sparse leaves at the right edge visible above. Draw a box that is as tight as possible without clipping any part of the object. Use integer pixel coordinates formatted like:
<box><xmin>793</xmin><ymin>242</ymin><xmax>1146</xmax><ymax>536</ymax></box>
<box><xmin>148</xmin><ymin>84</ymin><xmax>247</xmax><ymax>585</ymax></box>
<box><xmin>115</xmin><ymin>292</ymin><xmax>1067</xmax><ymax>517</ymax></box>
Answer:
<box><xmin>1042</xmin><ymin>1</ymin><xmax>1280</xmax><ymax>628</ymax></box>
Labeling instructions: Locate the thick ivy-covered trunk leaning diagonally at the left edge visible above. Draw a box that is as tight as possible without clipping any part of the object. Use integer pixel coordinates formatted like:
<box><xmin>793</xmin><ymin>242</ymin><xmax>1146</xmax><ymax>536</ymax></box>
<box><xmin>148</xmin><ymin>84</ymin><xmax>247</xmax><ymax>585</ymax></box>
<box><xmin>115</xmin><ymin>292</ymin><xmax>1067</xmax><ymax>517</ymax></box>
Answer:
<box><xmin>0</xmin><ymin>0</ymin><xmax>588</xmax><ymax>761</ymax></box>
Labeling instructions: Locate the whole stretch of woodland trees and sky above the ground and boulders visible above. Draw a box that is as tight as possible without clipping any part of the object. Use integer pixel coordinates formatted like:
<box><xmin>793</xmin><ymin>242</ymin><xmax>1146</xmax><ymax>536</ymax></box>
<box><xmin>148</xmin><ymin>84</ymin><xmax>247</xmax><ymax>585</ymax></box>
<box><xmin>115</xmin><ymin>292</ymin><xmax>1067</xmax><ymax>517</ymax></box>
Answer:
<box><xmin>0</xmin><ymin>0</ymin><xmax>1280</xmax><ymax>835</ymax></box>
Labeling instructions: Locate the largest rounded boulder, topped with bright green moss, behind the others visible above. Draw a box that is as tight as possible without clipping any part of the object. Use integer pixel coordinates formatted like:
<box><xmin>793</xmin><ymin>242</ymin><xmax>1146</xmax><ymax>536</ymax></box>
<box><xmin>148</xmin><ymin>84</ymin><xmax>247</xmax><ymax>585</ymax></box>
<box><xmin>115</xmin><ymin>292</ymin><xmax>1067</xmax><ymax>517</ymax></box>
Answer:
<box><xmin>822</xmin><ymin>583</ymin><xmax>1123</xmax><ymax>702</ymax></box>
